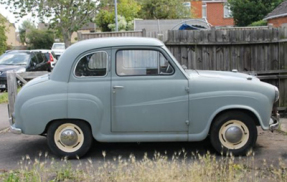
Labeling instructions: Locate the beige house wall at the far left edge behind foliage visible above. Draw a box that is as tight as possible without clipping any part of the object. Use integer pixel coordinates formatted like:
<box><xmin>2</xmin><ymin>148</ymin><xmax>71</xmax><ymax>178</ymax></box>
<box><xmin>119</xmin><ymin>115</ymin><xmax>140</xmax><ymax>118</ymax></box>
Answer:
<box><xmin>0</xmin><ymin>14</ymin><xmax>22</xmax><ymax>48</ymax></box>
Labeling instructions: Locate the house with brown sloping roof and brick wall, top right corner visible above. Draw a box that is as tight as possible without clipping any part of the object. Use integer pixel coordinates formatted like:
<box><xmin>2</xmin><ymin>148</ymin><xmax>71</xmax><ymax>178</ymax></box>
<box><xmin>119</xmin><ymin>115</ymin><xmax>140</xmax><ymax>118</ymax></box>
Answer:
<box><xmin>263</xmin><ymin>1</ymin><xmax>287</xmax><ymax>27</ymax></box>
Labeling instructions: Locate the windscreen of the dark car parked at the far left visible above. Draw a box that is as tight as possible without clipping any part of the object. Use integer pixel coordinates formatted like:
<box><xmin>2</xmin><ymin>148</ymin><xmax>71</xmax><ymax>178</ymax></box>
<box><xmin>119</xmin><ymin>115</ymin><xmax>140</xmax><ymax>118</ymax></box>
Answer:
<box><xmin>0</xmin><ymin>53</ymin><xmax>30</xmax><ymax>65</ymax></box>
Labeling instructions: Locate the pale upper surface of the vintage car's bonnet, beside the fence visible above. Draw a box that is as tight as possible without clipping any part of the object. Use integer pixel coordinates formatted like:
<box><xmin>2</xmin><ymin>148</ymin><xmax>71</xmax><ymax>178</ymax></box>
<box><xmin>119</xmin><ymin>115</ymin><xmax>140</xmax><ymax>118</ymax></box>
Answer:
<box><xmin>185</xmin><ymin>70</ymin><xmax>259</xmax><ymax>80</ymax></box>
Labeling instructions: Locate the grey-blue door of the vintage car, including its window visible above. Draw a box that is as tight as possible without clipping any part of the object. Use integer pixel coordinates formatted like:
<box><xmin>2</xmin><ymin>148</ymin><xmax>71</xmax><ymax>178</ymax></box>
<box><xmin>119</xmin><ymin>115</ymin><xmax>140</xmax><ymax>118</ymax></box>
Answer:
<box><xmin>111</xmin><ymin>48</ymin><xmax>188</xmax><ymax>133</ymax></box>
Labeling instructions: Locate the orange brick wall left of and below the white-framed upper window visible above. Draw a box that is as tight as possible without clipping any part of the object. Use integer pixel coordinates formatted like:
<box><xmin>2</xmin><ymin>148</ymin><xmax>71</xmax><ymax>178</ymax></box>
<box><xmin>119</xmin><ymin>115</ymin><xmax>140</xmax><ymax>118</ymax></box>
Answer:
<box><xmin>206</xmin><ymin>2</ymin><xmax>234</xmax><ymax>26</ymax></box>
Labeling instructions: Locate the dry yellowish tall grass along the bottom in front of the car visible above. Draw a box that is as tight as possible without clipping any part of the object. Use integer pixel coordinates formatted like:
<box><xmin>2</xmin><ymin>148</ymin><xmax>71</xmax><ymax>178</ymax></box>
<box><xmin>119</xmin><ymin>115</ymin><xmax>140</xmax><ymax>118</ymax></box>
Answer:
<box><xmin>0</xmin><ymin>149</ymin><xmax>287</xmax><ymax>182</ymax></box>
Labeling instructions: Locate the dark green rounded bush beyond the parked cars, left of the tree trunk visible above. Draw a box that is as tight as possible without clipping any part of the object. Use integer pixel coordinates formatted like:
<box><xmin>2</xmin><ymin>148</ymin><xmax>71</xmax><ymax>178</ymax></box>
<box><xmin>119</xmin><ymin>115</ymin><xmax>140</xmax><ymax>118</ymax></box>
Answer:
<box><xmin>26</xmin><ymin>29</ymin><xmax>54</xmax><ymax>49</ymax></box>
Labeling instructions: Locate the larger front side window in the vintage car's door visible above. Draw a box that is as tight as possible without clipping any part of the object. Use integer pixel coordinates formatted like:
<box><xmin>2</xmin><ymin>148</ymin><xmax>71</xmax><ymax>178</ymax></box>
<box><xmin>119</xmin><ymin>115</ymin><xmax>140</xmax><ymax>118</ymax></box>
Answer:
<box><xmin>116</xmin><ymin>50</ymin><xmax>174</xmax><ymax>76</ymax></box>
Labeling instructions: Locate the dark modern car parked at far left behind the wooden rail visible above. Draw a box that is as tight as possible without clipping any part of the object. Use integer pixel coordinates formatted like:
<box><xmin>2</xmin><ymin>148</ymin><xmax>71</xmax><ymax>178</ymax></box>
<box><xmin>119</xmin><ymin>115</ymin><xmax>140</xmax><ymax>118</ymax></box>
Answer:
<box><xmin>0</xmin><ymin>50</ymin><xmax>51</xmax><ymax>91</ymax></box>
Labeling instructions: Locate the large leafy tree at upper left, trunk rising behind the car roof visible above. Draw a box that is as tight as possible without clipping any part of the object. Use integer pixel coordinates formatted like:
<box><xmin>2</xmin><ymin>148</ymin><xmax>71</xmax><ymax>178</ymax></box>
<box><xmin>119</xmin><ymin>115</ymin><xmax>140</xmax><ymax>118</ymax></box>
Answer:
<box><xmin>0</xmin><ymin>0</ymin><xmax>99</xmax><ymax>47</ymax></box>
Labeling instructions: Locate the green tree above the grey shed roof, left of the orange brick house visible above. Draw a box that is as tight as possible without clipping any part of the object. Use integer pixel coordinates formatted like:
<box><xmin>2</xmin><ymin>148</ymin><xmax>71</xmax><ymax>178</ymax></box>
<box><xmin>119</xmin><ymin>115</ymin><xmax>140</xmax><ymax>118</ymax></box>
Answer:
<box><xmin>139</xmin><ymin>0</ymin><xmax>191</xmax><ymax>19</ymax></box>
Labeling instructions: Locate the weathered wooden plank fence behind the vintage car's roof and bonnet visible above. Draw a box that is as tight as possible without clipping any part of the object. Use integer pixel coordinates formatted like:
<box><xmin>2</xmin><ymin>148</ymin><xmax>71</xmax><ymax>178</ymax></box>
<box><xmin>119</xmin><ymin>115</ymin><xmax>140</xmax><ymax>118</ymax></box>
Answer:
<box><xmin>79</xmin><ymin>27</ymin><xmax>287</xmax><ymax>107</ymax></box>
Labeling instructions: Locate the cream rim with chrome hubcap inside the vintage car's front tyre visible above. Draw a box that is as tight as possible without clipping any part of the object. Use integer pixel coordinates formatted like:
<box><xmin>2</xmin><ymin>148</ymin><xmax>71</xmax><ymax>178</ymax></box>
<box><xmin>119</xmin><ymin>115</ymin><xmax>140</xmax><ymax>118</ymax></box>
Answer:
<box><xmin>218</xmin><ymin>120</ymin><xmax>250</xmax><ymax>150</ymax></box>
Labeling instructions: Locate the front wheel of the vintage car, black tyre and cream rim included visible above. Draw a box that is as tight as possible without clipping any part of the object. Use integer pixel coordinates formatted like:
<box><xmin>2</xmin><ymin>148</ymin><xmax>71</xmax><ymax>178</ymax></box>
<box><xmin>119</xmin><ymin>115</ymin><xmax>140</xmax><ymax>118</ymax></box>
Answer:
<box><xmin>210</xmin><ymin>111</ymin><xmax>257</xmax><ymax>156</ymax></box>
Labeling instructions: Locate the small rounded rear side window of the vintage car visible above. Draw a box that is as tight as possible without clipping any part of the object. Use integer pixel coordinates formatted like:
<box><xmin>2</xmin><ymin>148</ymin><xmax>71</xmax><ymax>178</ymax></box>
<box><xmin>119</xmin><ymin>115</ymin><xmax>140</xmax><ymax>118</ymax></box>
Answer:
<box><xmin>75</xmin><ymin>51</ymin><xmax>108</xmax><ymax>77</ymax></box>
